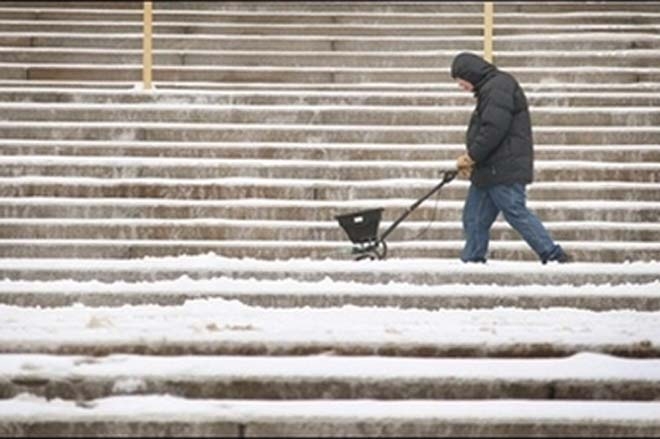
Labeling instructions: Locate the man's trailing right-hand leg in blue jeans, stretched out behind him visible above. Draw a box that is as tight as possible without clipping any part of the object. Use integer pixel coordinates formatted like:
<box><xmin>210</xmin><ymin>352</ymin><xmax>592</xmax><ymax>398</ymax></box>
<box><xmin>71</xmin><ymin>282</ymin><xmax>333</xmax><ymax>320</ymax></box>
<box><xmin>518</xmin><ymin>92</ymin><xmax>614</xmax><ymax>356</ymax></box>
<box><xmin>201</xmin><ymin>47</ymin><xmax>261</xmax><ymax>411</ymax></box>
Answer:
<box><xmin>490</xmin><ymin>183</ymin><xmax>563</xmax><ymax>263</ymax></box>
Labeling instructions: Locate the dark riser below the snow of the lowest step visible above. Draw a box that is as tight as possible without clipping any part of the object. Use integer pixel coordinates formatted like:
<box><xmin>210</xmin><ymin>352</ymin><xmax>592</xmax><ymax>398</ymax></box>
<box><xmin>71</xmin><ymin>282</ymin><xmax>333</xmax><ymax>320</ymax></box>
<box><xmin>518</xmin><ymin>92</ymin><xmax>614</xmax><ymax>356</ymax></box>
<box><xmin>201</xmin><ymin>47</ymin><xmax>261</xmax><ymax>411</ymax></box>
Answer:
<box><xmin>0</xmin><ymin>422</ymin><xmax>660</xmax><ymax>438</ymax></box>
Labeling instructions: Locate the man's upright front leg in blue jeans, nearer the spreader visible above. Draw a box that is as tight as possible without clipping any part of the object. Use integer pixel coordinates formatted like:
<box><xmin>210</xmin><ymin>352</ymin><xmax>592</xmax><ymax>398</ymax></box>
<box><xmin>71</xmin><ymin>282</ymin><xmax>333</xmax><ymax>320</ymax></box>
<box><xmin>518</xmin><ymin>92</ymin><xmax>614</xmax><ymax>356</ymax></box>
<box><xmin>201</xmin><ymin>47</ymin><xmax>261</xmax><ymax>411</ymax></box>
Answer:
<box><xmin>461</xmin><ymin>185</ymin><xmax>499</xmax><ymax>262</ymax></box>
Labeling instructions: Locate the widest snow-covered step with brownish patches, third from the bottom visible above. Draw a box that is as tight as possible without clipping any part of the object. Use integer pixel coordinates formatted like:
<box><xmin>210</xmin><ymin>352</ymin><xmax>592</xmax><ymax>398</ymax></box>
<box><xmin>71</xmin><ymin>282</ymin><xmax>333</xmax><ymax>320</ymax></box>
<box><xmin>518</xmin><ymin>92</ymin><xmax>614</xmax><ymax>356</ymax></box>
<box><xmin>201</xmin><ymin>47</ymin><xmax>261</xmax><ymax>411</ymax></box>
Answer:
<box><xmin>0</xmin><ymin>299</ymin><xmax>660</xmax><ymax>358</ymax></box>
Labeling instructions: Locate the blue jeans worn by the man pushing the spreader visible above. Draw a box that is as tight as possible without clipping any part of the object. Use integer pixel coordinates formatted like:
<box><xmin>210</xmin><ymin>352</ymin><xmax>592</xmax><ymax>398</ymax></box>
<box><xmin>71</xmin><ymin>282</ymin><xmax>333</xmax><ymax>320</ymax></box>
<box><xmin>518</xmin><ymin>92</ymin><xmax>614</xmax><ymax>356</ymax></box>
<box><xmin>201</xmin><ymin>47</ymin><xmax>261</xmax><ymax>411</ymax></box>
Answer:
<box><xmin>461</xmin><ymin>183</ymin><xmax>562</xmax><ymax>262</ymax></box>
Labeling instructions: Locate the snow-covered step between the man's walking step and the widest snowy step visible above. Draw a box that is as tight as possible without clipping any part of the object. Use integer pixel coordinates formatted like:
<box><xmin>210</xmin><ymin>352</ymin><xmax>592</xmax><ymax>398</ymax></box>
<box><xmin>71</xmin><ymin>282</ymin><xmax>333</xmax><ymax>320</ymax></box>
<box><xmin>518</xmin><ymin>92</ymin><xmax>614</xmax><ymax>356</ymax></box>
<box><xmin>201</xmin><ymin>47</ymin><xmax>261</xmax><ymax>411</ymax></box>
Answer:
<box><xmin>0</xmin><ymin>274</ymin><xmax>660</xmax><ymax>311</ymax></box>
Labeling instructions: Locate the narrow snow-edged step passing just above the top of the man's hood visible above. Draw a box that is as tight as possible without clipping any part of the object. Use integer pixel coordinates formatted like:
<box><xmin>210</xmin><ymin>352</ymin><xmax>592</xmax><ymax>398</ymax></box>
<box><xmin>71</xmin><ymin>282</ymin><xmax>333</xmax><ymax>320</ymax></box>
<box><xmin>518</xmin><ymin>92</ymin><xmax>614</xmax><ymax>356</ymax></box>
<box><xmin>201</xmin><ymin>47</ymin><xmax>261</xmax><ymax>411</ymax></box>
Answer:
<box><xmin>5</xmin><ymin>31</ymin><xmax>660</xmax><ymax>53</ymax></box>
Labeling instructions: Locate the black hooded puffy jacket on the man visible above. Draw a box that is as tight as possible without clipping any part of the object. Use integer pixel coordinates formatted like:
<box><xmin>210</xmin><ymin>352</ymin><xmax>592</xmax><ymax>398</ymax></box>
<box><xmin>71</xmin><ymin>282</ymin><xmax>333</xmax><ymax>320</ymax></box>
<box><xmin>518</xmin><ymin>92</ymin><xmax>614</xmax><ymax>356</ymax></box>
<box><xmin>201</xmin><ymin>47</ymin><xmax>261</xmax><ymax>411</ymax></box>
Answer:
<box><xmin>451</xmin><ymin>52</ymin><xmax>534</xmax><ymax>187</ymax></box>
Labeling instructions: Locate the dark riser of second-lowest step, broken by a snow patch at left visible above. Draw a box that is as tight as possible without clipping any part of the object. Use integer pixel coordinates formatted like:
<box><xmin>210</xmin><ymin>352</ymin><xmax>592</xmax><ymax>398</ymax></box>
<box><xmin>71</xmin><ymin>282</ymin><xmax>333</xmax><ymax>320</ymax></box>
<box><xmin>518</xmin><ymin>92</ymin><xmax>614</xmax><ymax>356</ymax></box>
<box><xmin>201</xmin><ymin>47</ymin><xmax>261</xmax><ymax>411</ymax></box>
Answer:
<box><xmin>0</xmin><ymin>377</ymin><xmax>660</xmax><ymax>401</ymax></box>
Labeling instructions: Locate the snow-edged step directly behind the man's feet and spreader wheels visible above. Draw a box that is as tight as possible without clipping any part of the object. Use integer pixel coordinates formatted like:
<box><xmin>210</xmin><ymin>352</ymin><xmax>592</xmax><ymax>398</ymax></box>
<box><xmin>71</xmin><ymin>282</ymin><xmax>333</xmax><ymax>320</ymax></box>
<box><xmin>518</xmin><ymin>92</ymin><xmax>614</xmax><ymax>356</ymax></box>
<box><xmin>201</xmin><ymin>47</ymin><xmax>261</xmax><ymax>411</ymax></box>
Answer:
<box><xmin>0</xmin><ymin>239</ymin><xmax>660</xmax><ymax>262</ymax></box>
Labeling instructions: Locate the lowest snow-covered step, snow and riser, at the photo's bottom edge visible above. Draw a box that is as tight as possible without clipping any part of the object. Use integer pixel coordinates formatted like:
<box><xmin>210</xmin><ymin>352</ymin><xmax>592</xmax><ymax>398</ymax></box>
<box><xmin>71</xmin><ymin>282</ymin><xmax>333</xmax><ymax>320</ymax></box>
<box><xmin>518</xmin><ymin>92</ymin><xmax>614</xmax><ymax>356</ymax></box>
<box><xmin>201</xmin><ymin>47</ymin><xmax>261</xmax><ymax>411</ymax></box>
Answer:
<box><xmin>5</xmin><ymin>395</ymin><xmax>660</xmax><ymax>437</ymax></box>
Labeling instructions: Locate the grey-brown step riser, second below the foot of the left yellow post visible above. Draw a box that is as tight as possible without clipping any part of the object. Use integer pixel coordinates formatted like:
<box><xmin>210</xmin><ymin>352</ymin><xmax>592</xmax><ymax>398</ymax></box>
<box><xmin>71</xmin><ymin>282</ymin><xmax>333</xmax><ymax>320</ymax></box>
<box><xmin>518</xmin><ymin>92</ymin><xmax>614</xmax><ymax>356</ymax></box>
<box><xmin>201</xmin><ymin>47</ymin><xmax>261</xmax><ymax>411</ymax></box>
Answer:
<box><xmin>5</xmin><ymin>106</ymin><xmax>660</xmax><ymax>127</ymax></box>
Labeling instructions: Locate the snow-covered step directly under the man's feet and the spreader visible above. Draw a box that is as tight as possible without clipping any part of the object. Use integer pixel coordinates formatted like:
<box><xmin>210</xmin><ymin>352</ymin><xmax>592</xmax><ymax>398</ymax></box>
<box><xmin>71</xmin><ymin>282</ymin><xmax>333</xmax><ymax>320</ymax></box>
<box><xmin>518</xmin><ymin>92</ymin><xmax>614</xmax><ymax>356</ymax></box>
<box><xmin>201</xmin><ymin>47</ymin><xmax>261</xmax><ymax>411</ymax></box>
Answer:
<box><xmin>0</xmin><ymin>256</ymin><xmax>660</xmax><ymax>292</ymax></box>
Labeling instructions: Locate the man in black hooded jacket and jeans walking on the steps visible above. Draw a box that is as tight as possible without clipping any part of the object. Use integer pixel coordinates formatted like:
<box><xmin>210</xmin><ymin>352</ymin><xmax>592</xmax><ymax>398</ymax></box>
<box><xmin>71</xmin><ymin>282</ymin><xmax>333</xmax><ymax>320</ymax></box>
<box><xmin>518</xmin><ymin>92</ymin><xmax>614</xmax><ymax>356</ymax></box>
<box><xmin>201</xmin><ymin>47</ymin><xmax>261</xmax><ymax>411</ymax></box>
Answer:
<box><xmin>451</xmin><ymin>52</ymin><xmax>572</xmax><ymax>264</ymax></box>
